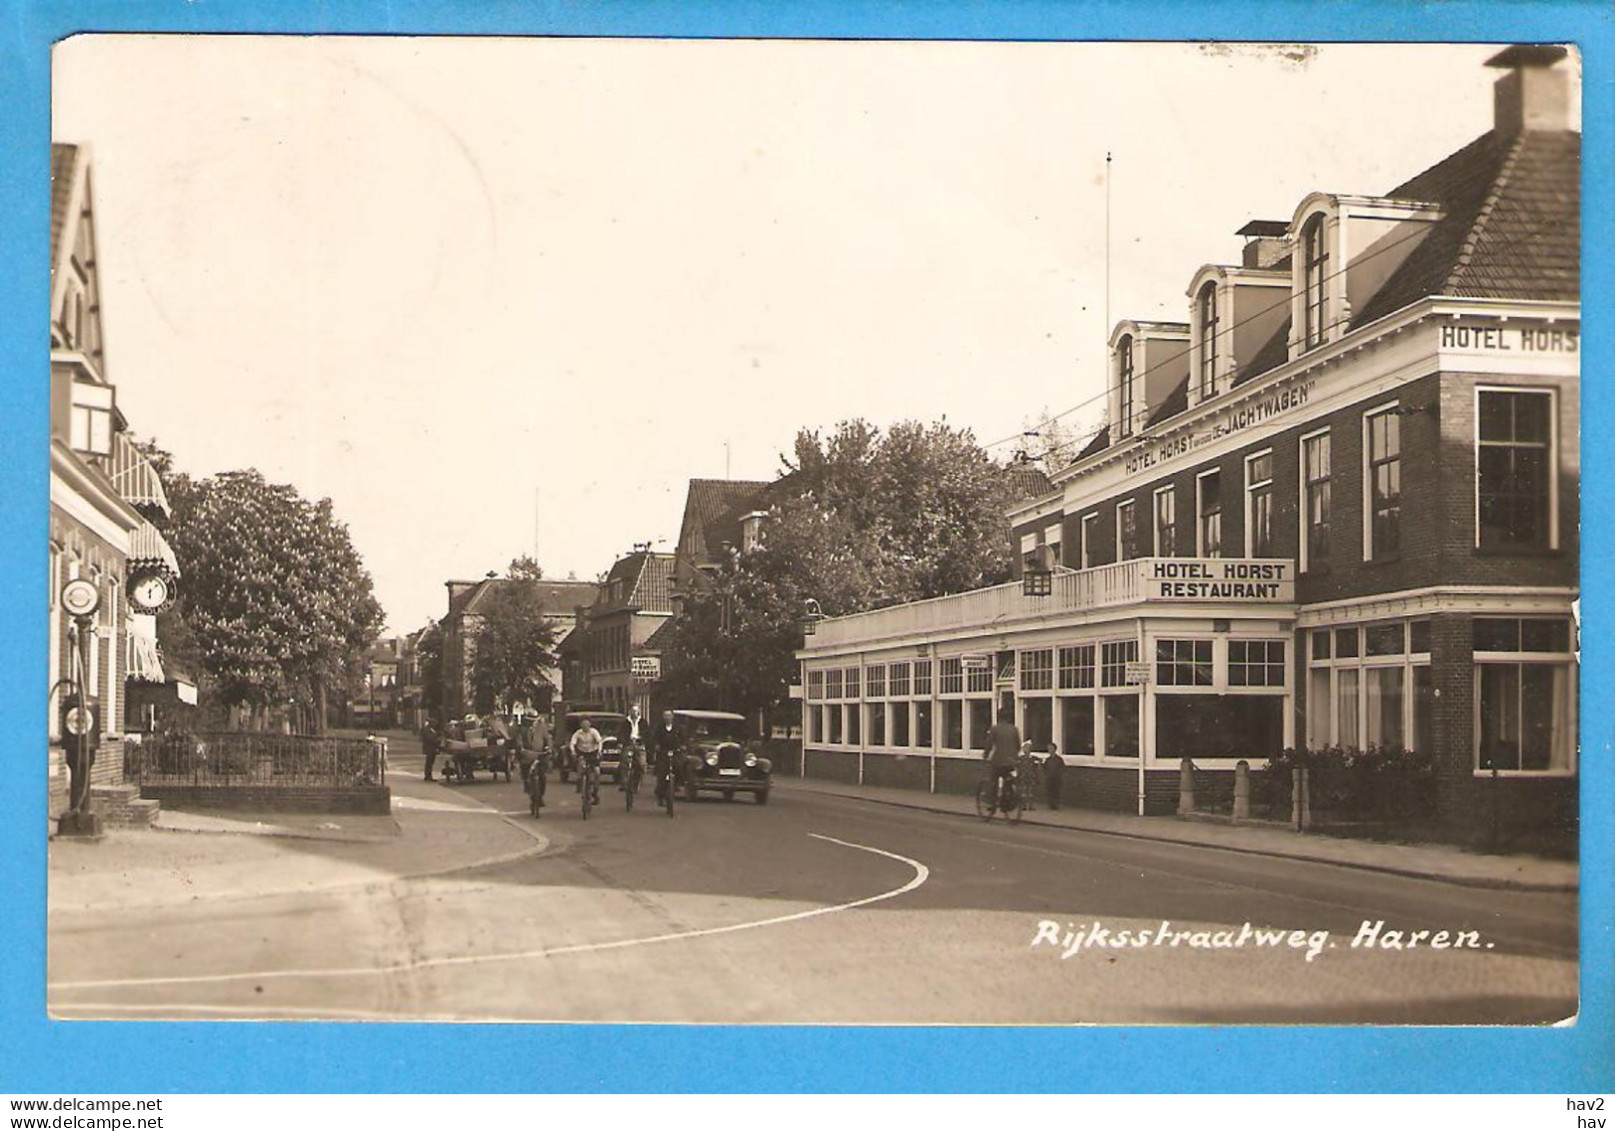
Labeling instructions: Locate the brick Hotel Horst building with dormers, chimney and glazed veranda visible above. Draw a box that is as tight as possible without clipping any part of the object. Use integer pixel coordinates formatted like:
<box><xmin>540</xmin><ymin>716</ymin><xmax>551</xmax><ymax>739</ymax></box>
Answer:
<box><xmin>801</xmin><ymin>47</ymin><xmax>1581</xmax><ymax>832</ymax></box>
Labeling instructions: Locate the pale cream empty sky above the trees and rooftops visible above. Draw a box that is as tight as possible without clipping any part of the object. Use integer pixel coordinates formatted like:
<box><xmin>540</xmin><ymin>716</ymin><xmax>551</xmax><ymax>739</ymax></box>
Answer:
<box><xmin>52</xmin><ymin>36</ymin><xmax>1563</xmax><ymax>632</ymax></box>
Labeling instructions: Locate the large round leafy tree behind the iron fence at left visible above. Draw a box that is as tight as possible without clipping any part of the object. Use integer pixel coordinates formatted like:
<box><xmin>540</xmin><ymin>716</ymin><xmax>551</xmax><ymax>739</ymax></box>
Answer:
<box><xmin>168</xmin><ymin>470</ymin><xmax>383</xmax><ymax>730</ymax></box>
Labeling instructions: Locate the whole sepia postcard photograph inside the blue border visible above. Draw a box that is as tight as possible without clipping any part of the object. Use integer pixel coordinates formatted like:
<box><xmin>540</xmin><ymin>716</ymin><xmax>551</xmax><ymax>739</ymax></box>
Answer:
<box><xmin>34</xmin><ymin>29</ymin><xmax>1607</xmax><ymax>1053</ymax></box>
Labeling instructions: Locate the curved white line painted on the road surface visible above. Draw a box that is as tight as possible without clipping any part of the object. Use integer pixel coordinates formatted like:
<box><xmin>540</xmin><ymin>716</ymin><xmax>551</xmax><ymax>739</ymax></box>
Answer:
<box><xmin>50</xmin><ymin>832</ymin><xmax>930</xmax><ymax>1008</ymax></box>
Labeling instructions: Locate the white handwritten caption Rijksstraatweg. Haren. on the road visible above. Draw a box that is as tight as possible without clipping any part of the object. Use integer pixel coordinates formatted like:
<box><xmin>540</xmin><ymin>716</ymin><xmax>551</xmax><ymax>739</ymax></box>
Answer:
<box><xmin>1032</xmin><ymin>919</ymin><xmax>1492</xmax><ymax>961</ymax></box>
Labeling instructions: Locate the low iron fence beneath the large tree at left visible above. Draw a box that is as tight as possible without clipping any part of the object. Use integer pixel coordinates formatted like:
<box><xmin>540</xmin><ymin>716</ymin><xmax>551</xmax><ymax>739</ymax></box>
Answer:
<box><xmin>123</xmin><ymin>730</ymin><xmax>386</xmax><ymax>788</ymax></box>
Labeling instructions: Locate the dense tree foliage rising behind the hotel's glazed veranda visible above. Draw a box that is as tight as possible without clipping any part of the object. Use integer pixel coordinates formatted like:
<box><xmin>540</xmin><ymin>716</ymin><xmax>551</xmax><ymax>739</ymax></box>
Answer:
<box><xmin>662</xmin><ymin>420</ymin><xmax>1011</xmax><ymax>713</ymax></box>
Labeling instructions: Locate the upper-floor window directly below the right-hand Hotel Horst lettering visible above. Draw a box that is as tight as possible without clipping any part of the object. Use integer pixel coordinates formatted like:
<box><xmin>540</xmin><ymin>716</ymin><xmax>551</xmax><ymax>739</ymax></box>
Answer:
<box><xmin>1474</xmin><ymin>389</ymin><xmax>1555</xmax><ymax>549</ymax></box>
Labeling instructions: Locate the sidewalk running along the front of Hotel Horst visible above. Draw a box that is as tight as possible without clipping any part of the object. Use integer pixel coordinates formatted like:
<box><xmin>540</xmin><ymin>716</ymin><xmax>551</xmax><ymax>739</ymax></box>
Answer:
<box><xmin>774</xmin><ymin>776</ymin><xmax>1579</xmax><ymax>892</ymax></box>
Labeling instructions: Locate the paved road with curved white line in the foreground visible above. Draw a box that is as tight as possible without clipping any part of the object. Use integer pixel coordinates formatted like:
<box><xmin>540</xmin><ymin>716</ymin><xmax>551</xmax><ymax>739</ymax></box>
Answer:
<box><xmin>50</xmin><ymin>743</ymin><xmax>1576</xmax><ymax>1024</ymax></box>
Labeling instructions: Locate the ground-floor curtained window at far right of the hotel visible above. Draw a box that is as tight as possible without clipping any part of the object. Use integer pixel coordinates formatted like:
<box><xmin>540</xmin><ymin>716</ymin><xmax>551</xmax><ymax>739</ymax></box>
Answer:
<box><xmin>1474</xmin><ymin>617</ymin><xmax>1576</xmax><ymax>774</ymax></box>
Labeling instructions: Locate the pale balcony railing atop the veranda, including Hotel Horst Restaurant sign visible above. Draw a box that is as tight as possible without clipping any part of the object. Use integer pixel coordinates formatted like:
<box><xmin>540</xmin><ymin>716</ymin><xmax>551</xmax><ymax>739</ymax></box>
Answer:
<box><xmin>808</xmin><ymin>557</ymin><xmax>1295</xmax><ymax>651</ymax></box>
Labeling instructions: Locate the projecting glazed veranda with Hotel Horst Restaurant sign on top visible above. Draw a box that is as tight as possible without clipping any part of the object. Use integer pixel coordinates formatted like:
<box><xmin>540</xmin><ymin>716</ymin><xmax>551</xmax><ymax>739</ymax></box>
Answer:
<box><xmin>801</xmin><ymin>559</ymin><xmax>1297</xmax><ymax>813</ymax></box>
